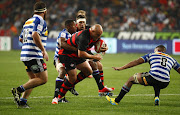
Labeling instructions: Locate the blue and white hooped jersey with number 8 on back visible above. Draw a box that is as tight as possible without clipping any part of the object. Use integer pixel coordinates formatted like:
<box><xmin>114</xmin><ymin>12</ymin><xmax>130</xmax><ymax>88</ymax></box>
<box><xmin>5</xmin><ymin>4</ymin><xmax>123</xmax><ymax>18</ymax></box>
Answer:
<box><xmin>141</xmin><ymin>52</ymin><xmax>180</xmax><ymax>82</ymax></box>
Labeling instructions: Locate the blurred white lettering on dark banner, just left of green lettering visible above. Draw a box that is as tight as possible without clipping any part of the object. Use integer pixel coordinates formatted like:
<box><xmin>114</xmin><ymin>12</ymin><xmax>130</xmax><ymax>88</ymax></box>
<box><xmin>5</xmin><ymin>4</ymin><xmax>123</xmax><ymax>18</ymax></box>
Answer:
<box><xmin>117</xmin><ymin>32</ymin><xmax>155</xmax><ymax>40</ymax></box>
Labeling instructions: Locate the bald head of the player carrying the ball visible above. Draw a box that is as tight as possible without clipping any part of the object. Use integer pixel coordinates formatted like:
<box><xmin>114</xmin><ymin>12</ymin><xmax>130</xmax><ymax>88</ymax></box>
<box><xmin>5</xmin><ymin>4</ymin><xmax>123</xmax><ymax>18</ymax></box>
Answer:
<box><xmin>90</xmin><ymin>24</ymin><xmax>103</xmax><ymax>40</ymax></box>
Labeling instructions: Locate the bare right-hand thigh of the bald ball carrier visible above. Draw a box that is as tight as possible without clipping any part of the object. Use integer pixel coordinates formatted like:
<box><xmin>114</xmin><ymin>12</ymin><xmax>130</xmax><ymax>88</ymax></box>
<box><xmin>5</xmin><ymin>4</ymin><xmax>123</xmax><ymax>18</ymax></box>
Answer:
<box><xmin>77</xmin><ymin>61</ymin><xmax>93</xmax><ymax>76</ymax></box>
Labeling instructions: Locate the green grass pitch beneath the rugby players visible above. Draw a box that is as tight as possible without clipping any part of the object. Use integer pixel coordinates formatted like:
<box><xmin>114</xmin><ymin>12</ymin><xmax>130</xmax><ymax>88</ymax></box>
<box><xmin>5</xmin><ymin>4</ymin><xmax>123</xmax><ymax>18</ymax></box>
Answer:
<box><xmin>0</xmin><ymin>51</ymin><xmax>180</xmax><ymax>115</ymax></box>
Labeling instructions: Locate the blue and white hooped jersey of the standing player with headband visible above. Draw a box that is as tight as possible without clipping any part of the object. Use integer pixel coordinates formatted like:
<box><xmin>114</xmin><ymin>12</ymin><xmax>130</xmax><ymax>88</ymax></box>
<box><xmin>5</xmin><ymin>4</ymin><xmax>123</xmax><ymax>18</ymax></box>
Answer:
<box><xmin>19</xmin><ymin>14</ymin><xmax>48</xmax><ymax>61</ymax></box>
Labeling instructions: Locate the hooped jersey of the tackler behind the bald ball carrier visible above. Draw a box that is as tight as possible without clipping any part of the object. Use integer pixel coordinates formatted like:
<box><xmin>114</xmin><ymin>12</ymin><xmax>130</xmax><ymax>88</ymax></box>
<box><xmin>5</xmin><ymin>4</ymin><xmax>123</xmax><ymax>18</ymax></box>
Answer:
<box><xmin>54</xmin><ymin>29</ymin><xmax>71</xmax><ymax>60</ymax></box>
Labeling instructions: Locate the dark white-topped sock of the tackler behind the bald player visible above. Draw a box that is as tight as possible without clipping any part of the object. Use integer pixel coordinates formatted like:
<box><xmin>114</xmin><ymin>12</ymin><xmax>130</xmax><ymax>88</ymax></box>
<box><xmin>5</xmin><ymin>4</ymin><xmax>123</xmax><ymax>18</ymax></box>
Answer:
<box><xmin>54</xmin><ymin>77</ymin><xmax>64</xmax><ymax>98</ymax></box>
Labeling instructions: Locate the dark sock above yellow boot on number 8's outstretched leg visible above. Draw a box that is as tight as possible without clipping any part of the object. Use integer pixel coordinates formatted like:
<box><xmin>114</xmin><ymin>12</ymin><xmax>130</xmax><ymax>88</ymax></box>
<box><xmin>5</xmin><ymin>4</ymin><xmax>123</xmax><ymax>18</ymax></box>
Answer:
<box><xmin>115</xmin><ymin>85</ymin><xmax>131</xmax><ymax>103</ymax></box>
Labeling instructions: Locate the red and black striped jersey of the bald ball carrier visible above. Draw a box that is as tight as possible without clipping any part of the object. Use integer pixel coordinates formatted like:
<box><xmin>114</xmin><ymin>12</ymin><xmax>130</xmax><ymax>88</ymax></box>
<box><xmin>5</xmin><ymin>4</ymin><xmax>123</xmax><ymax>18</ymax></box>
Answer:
<box><xmin>58</xmin><ymin>29</ymin><xmax>96</xmax><ymax>58</ymax></box>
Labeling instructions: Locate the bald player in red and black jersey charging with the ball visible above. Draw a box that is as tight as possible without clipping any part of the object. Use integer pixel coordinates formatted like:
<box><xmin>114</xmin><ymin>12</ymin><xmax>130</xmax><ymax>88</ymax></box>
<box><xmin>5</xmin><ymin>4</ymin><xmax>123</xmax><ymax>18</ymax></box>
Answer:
<box><xmin>58</xmin><ymin>24</ymin><xmax>103</xmax><ymax>98</ymax></box>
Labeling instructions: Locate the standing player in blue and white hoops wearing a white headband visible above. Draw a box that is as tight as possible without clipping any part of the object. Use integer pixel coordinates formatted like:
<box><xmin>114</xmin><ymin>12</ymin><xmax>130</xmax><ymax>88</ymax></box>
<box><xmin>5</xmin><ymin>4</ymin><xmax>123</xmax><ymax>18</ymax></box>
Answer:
<box><xmin>12</xmin><ymin>1</ymin><xmax>49</xmax><ymax>108</ymax></box>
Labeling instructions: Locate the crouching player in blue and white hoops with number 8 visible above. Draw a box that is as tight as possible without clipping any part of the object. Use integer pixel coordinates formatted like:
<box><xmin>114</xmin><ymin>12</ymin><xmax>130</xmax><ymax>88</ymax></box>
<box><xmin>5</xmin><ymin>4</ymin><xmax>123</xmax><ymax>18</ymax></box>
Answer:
<box><xmin>106</xmin><ymin>45</ymin><xmax>180</xmax><ymax>105</ymax></box>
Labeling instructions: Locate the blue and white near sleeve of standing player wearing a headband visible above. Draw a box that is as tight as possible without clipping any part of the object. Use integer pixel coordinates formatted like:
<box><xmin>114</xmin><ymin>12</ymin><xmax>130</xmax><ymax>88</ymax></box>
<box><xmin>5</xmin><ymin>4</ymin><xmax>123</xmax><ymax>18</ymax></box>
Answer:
<box><xmin>33</xmin><ymin>18</ymin><xmax>43</xmax><ymax>35</ymax></box>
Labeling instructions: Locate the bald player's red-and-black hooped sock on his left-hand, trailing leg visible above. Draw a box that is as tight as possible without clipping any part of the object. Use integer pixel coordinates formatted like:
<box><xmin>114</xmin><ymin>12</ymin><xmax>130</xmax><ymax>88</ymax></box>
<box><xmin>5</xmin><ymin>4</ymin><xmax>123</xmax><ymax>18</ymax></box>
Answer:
<box><xmin>58</xmin><ymin>80</ymin><xmax>74</xmax><ymax>99</ymax></box>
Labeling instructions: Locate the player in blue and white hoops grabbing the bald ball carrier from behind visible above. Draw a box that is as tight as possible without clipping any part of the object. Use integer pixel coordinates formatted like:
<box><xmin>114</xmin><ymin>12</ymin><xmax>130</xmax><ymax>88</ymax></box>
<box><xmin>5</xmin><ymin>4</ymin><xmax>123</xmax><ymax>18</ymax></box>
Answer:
<box><xmin>52</xmin><ymin>19</ymin><xmax>78</xmax><ymax>104</ymax></box>
